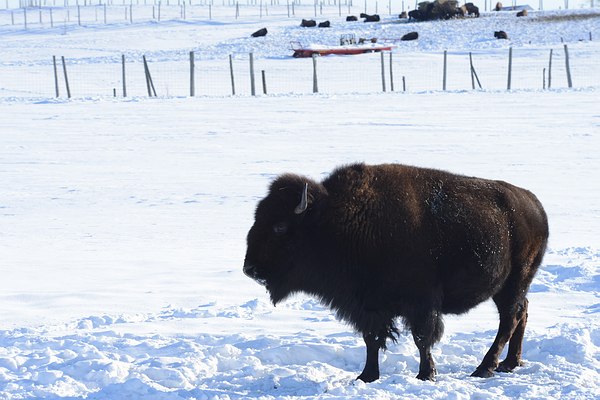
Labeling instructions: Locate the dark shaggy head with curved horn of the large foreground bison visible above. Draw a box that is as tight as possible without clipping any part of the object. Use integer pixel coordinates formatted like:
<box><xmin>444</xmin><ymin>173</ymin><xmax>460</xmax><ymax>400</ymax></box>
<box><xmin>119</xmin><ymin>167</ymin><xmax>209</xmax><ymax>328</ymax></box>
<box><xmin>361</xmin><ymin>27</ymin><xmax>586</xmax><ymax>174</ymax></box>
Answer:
<box><xmin>244</xmin><ymin>175</ymin><xmax>324</xmax><ymax>304</ymax></box>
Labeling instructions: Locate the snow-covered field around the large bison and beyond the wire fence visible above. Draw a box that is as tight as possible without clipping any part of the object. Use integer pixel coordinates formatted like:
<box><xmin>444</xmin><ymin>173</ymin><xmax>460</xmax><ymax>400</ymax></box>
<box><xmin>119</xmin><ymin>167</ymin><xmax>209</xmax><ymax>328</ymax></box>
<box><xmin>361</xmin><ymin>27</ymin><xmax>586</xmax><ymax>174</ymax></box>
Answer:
<box><xmin>0</xmin><ymin>3</ymin><xmax>600</xmax><ymax>400</ymax></box>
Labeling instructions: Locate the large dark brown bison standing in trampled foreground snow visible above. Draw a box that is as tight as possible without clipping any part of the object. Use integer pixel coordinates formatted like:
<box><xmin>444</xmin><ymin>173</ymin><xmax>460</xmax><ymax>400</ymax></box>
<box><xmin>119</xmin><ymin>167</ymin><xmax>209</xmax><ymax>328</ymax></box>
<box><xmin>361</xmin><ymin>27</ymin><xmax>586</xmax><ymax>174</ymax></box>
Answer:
<box><xmin>244</xmin><ymin>164</ymin><xmax>548</xmax><ymax>382</ymax></box>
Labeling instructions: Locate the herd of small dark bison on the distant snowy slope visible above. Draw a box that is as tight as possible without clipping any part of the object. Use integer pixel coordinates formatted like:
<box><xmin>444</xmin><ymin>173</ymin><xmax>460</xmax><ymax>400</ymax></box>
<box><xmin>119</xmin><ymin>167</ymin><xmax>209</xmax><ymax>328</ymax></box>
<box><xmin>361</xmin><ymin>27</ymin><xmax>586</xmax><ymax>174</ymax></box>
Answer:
<box><xmin>251</xmin><ymin>0</ymin><xmax>527</xmax><ymax>40</ymax></box>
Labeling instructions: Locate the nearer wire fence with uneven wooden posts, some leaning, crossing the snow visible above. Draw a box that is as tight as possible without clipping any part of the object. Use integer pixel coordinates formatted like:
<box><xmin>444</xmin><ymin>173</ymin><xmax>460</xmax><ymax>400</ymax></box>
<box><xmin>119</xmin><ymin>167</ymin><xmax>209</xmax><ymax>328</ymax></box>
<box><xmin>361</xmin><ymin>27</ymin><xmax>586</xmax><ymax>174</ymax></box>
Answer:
<box><xmin>0</xmin><ymin>45</ymin><xmax>600</xmax><ymax>98</ymax></box>
